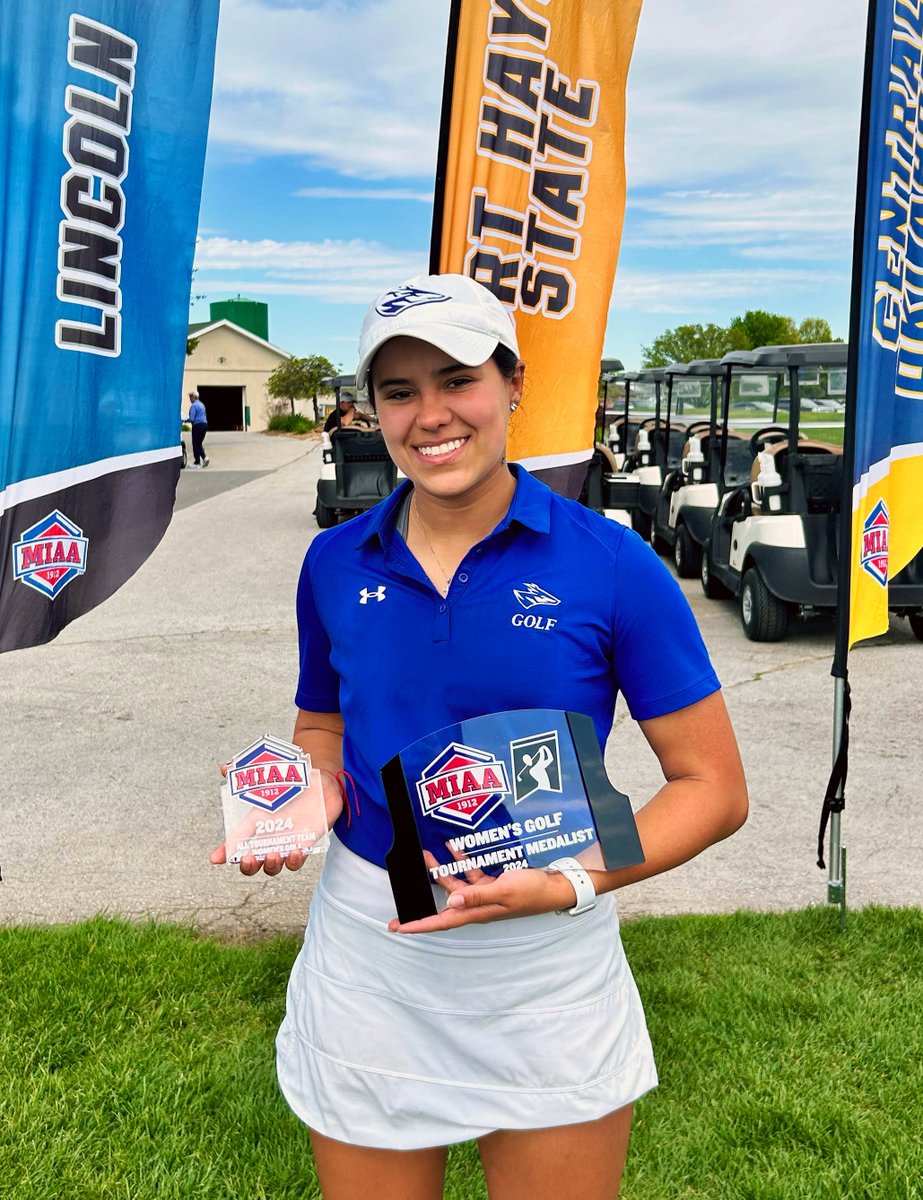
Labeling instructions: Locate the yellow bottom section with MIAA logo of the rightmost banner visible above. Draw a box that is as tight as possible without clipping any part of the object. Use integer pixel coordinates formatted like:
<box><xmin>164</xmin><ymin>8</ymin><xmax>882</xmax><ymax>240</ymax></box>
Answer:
<box><xmin>849</xmin><ymin>445</ymin><xmax>923</xmax><ymax>646</ymax></box>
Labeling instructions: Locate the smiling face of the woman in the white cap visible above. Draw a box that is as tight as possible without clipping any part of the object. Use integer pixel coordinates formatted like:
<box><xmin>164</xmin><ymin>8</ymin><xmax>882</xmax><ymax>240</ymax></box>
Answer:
<box><xmin>371</xmin><ymin>337</ymin><xmax>522</xmax><ymax>502</ymax></box>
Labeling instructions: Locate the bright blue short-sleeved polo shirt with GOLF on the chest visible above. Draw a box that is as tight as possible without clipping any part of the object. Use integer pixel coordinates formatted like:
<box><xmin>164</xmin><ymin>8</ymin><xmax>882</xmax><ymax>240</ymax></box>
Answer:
<box><xmin>295</xmin><ymin>466</ymin><xmax>720</xmax><ymax>866</ymax></box>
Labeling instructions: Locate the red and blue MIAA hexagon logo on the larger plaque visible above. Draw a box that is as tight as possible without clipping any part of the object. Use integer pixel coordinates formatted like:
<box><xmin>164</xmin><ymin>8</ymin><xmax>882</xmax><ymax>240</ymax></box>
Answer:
<box><xmin>416</xmin><ymin>742</ymin><xmax>510</xmax><ymax>829</ymax></box>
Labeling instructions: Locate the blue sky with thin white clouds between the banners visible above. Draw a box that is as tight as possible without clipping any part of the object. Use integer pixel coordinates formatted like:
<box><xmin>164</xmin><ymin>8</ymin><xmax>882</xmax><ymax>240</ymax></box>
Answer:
<box><xmin>191</xmin><ymin>0</ymin><xmax>867</xmax><ymax>373</ymax></box>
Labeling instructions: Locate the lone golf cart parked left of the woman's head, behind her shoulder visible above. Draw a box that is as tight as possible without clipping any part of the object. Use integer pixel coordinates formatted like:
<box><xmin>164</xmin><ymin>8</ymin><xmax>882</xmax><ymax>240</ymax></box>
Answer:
<box><xmin>314</xmin><ymin>376</ymin><xmax>397</xmax><ymax>529</ymax></box>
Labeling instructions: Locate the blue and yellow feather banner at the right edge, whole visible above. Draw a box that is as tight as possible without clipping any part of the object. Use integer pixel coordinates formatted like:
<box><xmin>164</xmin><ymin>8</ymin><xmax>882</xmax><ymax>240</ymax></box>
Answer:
<box><xmin>849</xmin><ymin>0</ymin><xmax>923</xmax><ymax>644</ymax></box>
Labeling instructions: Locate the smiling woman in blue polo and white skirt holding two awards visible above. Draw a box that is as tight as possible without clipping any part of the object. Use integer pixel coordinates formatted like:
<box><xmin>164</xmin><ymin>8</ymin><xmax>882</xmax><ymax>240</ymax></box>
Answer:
<box><xmin>212</xmin><ymin>275</ymin><xmax>747</xmax><ymax>1200</ymax></box>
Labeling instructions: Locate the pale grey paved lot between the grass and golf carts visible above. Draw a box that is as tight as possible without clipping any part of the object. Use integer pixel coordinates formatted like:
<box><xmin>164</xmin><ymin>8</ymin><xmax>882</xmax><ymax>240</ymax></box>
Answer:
<box><xmin>0</xmin><ymin>433</ymin><xmax>923</xmax><ymax>936</ymax></box>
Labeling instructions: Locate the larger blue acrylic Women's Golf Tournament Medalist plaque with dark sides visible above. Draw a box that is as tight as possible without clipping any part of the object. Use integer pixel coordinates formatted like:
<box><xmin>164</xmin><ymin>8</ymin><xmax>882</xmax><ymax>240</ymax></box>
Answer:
<box><xmin>382</xmin><ymin>708</ymin><xmax>645</xmax><ymax>922</ymax></box>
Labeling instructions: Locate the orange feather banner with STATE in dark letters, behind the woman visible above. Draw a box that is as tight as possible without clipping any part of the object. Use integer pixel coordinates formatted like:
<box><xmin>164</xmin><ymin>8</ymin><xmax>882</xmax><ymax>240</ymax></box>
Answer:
<box><xmin>437</xmin><ymin>0</ymin><xmax>641</xmax><ymax>469</ymax></box>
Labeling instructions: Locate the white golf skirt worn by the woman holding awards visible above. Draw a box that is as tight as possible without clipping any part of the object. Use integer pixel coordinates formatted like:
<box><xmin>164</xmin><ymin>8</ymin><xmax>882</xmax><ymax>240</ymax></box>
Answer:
<box><xmin>276</xmin><ymin>838</ymin><xmax>657</xmax><ymax>1150</ymax></box>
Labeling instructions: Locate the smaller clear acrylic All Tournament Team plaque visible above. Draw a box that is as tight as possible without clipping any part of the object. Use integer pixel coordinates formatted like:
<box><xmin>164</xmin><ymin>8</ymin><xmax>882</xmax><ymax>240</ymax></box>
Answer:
<box><xmin>221</xmin><ymin>737</ymin><xmax>330</xmax><ymax>863</ymax></box>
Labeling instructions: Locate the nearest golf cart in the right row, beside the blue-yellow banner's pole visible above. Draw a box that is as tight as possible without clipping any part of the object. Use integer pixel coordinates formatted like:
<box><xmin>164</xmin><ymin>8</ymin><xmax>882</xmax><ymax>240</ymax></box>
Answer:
<box><xmin>700</xmin><ymin>342</ymin><xmax>847</xmax><ymax>642</ymax></box>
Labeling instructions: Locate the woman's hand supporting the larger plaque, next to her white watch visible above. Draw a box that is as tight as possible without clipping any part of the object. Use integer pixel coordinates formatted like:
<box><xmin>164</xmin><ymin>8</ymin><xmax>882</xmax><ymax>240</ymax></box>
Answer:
<box><xmin>388</xmin><ymin>851</ymin><xmax>575</xmax><ymax>934</ymax></box>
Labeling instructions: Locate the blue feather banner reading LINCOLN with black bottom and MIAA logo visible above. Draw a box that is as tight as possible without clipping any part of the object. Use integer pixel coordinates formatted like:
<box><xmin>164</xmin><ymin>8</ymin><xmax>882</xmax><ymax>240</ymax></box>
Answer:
<box><xmin>0</xmin><ymin>0</ymin><xmax>218</xmax><ymax>650</ymax></box>
